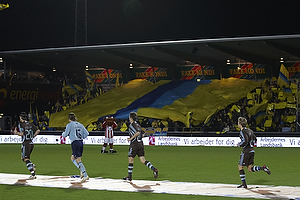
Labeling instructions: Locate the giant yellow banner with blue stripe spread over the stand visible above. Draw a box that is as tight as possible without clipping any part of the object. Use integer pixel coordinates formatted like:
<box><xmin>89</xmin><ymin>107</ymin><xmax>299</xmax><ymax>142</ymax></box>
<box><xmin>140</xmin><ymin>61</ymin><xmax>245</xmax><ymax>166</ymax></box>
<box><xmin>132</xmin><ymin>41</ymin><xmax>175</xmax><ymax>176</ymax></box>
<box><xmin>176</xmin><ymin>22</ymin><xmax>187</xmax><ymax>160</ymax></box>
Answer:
<box><xmin>49</xmin><ymin>78</ymin><xmax>262</xmax><ymax>127</ymax></box>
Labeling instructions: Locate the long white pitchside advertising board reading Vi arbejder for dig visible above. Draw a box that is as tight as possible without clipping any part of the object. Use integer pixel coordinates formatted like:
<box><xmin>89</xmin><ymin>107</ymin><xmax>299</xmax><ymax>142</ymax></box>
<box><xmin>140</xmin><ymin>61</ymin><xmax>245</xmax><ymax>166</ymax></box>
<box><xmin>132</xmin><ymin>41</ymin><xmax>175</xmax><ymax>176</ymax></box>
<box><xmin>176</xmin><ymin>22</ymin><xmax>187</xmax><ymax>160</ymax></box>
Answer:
<box><xmin>0</xmin><ymin>135</ymin><xmax>300</xmax><ymax>147</ymax></box>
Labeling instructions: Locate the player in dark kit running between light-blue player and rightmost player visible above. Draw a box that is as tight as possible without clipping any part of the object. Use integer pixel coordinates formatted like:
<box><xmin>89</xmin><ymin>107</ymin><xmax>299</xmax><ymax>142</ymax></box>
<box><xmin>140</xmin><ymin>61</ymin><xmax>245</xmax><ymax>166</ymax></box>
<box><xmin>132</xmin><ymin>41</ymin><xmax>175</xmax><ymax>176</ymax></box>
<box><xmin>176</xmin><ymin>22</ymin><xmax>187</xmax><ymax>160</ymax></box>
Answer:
<box><xmin>123</xmin><ymin>112</ymin><xmax>158</xmax><ymax>181</ymax></box>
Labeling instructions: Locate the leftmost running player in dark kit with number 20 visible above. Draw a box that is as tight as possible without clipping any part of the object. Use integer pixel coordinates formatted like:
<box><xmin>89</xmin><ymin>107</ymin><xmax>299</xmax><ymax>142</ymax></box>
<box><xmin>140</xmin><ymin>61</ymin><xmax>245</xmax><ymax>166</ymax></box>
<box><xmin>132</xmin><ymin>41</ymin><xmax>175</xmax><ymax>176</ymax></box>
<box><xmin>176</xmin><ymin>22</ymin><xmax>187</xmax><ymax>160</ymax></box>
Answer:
<box><xmin>14</xmin><ymin>112</ymin><xmax>40</xmax><ymax>179</ymax></box>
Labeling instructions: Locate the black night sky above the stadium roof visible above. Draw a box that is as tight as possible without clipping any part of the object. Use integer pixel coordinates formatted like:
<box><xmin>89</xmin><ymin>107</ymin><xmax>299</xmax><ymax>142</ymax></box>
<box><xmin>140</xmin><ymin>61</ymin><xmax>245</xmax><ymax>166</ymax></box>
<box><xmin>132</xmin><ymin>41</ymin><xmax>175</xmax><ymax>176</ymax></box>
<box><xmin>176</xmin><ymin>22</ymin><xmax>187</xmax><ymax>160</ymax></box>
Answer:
<box><xmin>0</xmin><ymin>0</ymin><xmax>300</xmax><ymax>50</ymax></box>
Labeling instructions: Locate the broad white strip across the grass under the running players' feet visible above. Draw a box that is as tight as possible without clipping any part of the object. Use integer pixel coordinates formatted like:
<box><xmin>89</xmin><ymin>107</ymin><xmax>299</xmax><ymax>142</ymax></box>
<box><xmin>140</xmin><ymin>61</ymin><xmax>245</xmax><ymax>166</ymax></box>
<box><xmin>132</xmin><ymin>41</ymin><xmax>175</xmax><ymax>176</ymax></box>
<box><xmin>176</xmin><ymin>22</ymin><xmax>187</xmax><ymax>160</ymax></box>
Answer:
<box><xmin>0</xmin><ymin>173</ymin><xmax>300</xmax><ymax>200</ymax></box>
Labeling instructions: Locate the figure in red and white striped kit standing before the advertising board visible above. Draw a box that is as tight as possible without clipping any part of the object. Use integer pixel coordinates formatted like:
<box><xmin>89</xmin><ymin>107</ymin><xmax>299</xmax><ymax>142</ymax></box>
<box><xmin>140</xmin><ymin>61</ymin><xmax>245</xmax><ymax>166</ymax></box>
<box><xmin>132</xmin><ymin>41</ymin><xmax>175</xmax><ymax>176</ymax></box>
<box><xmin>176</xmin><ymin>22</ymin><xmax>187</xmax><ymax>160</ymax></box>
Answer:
<box><xmin>101</xmin><ymin>117</ymin><xmax>117</xmax><ymax>153</ymax></box>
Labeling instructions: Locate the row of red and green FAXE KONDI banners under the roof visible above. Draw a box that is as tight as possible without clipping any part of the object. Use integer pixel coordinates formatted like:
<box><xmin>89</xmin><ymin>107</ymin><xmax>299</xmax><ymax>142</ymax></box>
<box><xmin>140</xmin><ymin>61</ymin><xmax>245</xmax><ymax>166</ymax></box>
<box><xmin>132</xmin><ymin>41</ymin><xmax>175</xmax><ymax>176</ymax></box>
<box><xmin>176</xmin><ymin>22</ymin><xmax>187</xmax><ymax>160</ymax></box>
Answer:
<box><xmin>89</xmin><ymin>62</ymin><xmax>300</xmax><ymax>84</ymax></box>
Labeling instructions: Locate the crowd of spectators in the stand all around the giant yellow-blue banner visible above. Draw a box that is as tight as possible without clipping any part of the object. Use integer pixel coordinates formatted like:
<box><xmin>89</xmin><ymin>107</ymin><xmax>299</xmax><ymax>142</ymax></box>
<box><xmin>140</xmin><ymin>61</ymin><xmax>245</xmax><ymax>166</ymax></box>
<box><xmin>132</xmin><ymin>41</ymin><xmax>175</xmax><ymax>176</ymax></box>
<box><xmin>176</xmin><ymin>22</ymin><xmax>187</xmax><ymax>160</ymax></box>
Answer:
<box><xmin>7</xmin><ymin>71</ymin><xmax>298</xmax><ymax>132</ymax></box>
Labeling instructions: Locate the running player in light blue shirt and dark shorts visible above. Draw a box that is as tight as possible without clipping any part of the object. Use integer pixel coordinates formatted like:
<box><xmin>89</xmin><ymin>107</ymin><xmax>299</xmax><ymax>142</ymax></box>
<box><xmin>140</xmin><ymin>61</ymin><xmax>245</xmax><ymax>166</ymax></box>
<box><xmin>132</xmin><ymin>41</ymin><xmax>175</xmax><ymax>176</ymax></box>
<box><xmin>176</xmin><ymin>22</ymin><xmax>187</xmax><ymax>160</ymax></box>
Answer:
<box><xmin>62</xmin><ymin>112</ymin><xmax>89</xmax><ymax>182</ymax></box>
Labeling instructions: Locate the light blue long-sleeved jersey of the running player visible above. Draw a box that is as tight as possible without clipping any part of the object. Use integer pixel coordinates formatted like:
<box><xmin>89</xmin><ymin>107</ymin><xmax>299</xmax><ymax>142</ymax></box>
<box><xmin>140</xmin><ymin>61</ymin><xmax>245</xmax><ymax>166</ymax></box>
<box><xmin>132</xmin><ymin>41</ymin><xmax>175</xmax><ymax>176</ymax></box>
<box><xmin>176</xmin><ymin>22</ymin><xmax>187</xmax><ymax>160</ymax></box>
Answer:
<box><xmin>62</xmin><ymin>121</ymin><xmax>89</xmax><ymax>143</ymax></box>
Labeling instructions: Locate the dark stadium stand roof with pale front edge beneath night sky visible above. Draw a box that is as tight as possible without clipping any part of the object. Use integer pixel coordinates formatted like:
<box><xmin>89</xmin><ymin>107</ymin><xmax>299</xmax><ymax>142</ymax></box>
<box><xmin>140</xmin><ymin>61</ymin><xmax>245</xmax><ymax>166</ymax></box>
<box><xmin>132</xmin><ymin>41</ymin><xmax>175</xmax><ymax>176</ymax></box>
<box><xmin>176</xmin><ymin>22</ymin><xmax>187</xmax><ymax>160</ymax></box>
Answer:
<box><xmin>0</xmin><ymin>34</ymin><xmax>300</xmax><ymax>76</ymax></box>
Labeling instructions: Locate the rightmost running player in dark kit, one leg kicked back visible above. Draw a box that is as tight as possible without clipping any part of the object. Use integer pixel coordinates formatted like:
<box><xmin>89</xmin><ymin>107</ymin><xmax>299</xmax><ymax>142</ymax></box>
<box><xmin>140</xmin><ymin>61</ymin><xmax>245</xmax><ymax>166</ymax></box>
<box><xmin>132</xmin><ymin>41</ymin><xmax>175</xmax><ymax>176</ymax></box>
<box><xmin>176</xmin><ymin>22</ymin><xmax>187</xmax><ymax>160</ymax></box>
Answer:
<box><xmin>237</xmin><ymin>117</ymin><xmax>271</xmax><ymax>188</ymax></box>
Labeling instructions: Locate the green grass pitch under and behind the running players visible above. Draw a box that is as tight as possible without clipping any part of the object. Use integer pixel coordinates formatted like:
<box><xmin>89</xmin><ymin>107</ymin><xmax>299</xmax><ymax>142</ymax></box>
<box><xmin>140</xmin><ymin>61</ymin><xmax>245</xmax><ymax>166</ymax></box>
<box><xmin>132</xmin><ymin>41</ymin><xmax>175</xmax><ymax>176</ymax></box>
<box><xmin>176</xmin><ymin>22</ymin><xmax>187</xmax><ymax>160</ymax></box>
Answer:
<box><xmin>0</xmin><ymin>144</ymin><xmax>300</xmax><ymax>200</ymax></box>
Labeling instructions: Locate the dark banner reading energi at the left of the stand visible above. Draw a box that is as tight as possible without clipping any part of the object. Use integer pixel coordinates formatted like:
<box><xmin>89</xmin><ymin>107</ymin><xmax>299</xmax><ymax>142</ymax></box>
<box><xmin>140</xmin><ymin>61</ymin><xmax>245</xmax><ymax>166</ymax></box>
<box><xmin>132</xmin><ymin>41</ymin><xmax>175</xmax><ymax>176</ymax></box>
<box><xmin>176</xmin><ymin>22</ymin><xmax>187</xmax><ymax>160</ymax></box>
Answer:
<box><xmin>0</xmin><ymin>82</ymin><xmax>62</xmax><ymax>116</ymax></box>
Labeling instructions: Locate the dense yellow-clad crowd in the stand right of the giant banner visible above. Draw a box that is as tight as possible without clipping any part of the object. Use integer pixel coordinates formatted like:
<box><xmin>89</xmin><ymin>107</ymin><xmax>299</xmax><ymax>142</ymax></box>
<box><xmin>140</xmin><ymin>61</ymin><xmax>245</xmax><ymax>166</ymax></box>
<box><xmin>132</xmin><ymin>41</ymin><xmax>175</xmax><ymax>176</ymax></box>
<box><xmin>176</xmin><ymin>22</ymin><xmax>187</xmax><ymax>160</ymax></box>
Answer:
<box><xmin>203</xmin><ymin>80</ymin><xmax>298</xmax><ymax>132</ymax></box>
